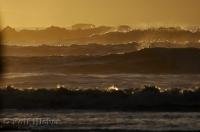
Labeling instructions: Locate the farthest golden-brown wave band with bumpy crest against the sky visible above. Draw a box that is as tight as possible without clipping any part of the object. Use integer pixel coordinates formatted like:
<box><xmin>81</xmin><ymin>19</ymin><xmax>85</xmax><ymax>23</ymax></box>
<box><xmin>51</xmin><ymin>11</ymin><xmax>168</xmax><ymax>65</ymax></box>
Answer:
<box><xmin>2</xmin><ymin>25</ymin><xmax>200</xmax><ymax>46</ymax></box>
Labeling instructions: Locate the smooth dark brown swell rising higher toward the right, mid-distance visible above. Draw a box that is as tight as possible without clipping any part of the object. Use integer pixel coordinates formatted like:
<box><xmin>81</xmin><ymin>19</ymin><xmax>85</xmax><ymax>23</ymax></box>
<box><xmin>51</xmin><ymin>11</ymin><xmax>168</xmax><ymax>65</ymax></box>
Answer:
<box><xmin>3</xmin><ymin>48</ymin><xmax>200</xmax><ymax>74</ymax></box>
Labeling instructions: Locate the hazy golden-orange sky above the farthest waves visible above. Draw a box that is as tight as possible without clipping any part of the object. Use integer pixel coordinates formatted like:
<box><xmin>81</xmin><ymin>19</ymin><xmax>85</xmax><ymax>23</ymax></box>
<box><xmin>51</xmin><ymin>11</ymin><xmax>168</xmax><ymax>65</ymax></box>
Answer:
<box><xmin>0</xmin><ymin>0</ymin><xmax>200</xmax><ymax>27</ymax></box>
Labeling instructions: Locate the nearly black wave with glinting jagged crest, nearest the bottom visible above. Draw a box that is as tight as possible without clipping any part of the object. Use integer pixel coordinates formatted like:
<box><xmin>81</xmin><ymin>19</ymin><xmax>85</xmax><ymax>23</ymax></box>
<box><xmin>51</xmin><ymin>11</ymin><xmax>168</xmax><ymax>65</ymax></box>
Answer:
<box><xmin>0</xmin><ymin>86</ymin><xmax>200</xmax><ymax>111</ymax></box>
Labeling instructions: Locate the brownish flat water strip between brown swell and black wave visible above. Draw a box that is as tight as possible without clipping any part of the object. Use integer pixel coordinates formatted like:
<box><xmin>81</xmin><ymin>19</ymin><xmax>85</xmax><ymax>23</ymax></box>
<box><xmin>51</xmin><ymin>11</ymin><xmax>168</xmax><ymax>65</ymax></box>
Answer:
<box><xmin>0</xmin><ymin>72</ymin><xmax>200</xmax><ymax>89</ymax></box>
